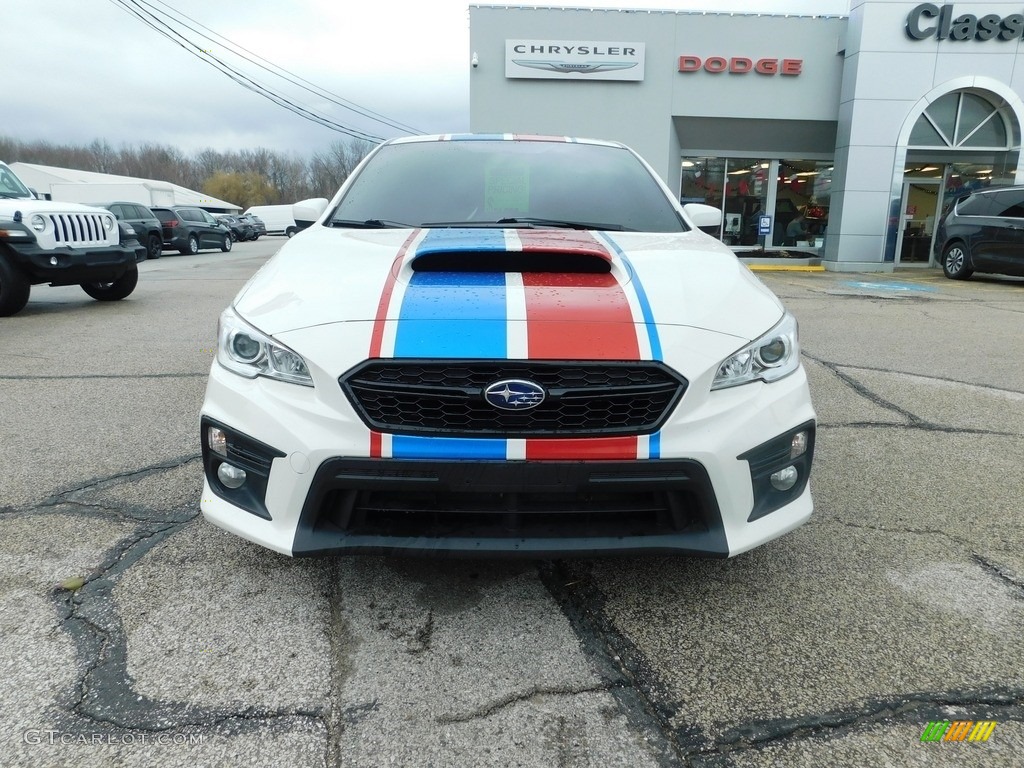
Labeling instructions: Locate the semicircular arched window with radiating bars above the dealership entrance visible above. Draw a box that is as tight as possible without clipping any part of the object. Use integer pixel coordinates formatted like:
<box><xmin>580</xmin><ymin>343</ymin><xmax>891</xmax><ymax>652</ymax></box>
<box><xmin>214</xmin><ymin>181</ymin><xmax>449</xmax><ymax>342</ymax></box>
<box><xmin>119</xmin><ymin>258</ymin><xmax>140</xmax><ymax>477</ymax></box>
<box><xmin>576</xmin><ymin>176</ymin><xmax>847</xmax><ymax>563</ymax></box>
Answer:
<box><xmin>910</xmin><ymin>91</ymin><xmax>1012</xmax><ymax>150</ymax></box>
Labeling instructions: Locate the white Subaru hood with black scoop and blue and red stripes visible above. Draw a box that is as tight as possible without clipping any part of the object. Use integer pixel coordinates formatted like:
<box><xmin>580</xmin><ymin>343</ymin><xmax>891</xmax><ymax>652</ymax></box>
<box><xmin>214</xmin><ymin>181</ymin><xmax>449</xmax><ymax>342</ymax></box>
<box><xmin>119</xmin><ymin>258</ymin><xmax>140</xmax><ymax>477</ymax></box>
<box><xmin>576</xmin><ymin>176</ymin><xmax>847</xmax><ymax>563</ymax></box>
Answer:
<box><xmin>234</xmin><ymin>226</ymin><xmax>783</xmax><ymax>340</ymax></box>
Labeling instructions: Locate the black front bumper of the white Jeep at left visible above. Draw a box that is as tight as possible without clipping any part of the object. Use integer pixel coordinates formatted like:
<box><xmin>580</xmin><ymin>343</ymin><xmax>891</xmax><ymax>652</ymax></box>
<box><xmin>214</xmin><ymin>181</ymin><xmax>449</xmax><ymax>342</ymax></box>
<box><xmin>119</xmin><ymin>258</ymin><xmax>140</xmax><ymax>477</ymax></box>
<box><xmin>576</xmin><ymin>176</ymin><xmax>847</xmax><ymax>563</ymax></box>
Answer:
<box><xmin>7</xmin><ymin>242</ymin><xmax>138</xmax><ymax>286</ymax></box>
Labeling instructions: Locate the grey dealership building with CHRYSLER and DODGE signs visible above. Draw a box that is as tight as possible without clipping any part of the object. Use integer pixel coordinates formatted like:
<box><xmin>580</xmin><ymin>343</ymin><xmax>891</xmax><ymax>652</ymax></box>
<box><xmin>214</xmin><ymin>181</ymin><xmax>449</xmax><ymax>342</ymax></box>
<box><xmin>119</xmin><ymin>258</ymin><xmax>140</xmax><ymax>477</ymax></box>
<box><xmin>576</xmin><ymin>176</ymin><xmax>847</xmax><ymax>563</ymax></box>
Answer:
<box><xmin>470</xmin><ymin>0</ymin><xmax>1024</xmax><ymax>271</ymax></box>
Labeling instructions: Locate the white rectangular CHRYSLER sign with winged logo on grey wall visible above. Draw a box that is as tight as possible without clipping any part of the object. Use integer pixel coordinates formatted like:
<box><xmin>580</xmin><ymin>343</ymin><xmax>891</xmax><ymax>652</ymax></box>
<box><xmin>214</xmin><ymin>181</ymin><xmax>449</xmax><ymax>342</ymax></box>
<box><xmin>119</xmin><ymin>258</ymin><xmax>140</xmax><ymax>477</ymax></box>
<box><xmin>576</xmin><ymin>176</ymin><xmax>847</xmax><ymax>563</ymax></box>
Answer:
<box><xmin>505</xmin><ymin>40</ymin><xmax>644</xmax><ymax>80</ymax></box>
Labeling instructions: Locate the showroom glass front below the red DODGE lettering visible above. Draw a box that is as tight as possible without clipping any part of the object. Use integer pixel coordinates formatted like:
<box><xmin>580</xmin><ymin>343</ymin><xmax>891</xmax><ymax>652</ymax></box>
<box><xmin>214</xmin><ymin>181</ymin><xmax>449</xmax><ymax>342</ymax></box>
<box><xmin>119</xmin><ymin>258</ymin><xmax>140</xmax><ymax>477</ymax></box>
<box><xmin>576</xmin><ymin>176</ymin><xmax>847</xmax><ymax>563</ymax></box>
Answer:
<box><xmin>680</xmin><ymin>157</ymin><xmax>833</xmax><ymax>256</ymax></box>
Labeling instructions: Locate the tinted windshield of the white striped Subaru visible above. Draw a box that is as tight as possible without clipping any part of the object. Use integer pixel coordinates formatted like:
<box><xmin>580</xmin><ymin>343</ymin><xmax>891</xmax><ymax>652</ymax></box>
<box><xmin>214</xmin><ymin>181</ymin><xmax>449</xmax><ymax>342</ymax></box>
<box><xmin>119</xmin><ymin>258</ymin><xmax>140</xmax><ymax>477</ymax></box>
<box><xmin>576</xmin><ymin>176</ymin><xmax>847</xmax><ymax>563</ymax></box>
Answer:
<box><xmin>330</xmin><ymin>139</ymin><xmax>685</xmax><ymax>232</ymax></box>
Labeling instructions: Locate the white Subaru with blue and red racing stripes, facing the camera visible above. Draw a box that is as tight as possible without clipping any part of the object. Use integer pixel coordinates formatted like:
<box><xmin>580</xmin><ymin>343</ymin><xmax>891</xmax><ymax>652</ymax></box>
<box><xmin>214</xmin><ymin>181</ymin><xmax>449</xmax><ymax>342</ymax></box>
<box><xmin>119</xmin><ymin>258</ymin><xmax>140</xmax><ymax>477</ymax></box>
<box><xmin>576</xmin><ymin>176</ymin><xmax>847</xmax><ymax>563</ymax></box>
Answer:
<box><xmin>200</xmin><ymin>134</ymin><xmax>815</xmax><ymax>557</ymax></box>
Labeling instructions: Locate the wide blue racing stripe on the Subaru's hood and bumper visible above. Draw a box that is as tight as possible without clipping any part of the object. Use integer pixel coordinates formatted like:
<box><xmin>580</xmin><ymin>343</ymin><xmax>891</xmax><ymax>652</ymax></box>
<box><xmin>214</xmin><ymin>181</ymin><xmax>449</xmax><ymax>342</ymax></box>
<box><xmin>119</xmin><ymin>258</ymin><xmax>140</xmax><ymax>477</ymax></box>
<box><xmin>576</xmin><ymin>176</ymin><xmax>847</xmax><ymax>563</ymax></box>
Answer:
<box><xmin>391</xmin><ymin>229</ymin><xmax>508</xmax><ymax>459</ymax></box>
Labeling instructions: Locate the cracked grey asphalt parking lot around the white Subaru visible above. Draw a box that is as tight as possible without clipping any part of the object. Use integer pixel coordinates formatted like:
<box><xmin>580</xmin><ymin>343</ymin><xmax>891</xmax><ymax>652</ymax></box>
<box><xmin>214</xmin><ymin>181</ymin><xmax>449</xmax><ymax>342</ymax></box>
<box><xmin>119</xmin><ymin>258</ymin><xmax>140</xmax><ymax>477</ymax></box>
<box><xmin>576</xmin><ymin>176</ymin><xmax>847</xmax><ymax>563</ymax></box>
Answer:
<box><xmin>0</xmin><ymin>236</ymin><xmax>1024</xmax><ymax>768</ymax></box>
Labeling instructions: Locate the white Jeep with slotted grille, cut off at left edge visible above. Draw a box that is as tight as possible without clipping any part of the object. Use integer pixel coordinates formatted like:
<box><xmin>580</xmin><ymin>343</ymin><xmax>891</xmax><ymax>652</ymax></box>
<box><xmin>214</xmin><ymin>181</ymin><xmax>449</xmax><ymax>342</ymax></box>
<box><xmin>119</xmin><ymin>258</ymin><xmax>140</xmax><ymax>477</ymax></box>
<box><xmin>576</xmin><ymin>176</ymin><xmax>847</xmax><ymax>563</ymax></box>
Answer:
<box><xmin>0</xmin><ymin>162</ymin><xmax>140</xmax><ymax>316</ymax></box>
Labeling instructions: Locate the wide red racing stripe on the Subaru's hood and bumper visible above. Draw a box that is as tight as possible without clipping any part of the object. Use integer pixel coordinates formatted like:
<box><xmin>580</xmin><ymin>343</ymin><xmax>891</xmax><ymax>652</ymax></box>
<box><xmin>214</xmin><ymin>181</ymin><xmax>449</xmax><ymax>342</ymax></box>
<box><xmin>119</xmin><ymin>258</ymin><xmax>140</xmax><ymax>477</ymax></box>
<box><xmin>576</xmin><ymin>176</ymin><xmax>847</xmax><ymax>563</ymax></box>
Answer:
<box><xmin>520</xmin><ymin>231</ymin><xmax>640</xmax><ymax>460</ymax></box>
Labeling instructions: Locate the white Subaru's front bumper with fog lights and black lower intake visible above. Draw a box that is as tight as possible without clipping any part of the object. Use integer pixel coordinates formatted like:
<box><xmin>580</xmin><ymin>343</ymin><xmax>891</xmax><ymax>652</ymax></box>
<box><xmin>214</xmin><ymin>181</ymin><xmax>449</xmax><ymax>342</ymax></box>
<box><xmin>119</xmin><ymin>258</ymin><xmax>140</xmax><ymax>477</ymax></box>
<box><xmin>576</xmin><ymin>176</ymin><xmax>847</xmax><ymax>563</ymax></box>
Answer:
<box><xmin>202</xmin><ymin>362</ymin><xmax>814</xmax><ymax>557</ymax></box>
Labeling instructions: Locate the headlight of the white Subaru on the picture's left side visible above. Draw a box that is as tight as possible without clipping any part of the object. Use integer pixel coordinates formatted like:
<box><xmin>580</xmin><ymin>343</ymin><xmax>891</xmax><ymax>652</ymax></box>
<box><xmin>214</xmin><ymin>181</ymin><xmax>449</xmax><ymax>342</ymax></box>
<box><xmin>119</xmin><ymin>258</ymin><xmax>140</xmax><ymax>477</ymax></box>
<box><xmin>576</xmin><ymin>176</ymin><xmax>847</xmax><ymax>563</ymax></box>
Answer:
<box><xmin>217</xmin><ymin>307</ymin><xmax>313</xmax><ymax>387</ymax></box>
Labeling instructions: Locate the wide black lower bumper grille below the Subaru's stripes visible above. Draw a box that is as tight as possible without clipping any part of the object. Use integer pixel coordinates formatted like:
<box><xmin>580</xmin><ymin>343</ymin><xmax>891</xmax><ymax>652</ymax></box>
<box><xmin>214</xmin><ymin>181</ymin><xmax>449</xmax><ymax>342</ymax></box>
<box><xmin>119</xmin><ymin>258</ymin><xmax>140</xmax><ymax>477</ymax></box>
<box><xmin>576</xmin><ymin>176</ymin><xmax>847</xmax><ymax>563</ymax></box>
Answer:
<box><xmin>292</xmin><ymin>458</ymin><xmax>729</xmax><ymax>557</ymax></box>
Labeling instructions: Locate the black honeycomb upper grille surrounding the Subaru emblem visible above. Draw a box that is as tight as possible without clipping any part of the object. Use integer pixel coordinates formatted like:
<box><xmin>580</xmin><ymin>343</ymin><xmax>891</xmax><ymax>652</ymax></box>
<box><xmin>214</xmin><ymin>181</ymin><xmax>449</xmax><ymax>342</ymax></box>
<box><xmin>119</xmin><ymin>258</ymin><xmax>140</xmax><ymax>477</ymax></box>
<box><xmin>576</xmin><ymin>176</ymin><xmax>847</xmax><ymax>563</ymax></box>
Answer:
<box><xmin>339</xmin><ymin>359</ymin><xmax>687</xmax><ymax>437</ymax></box>
